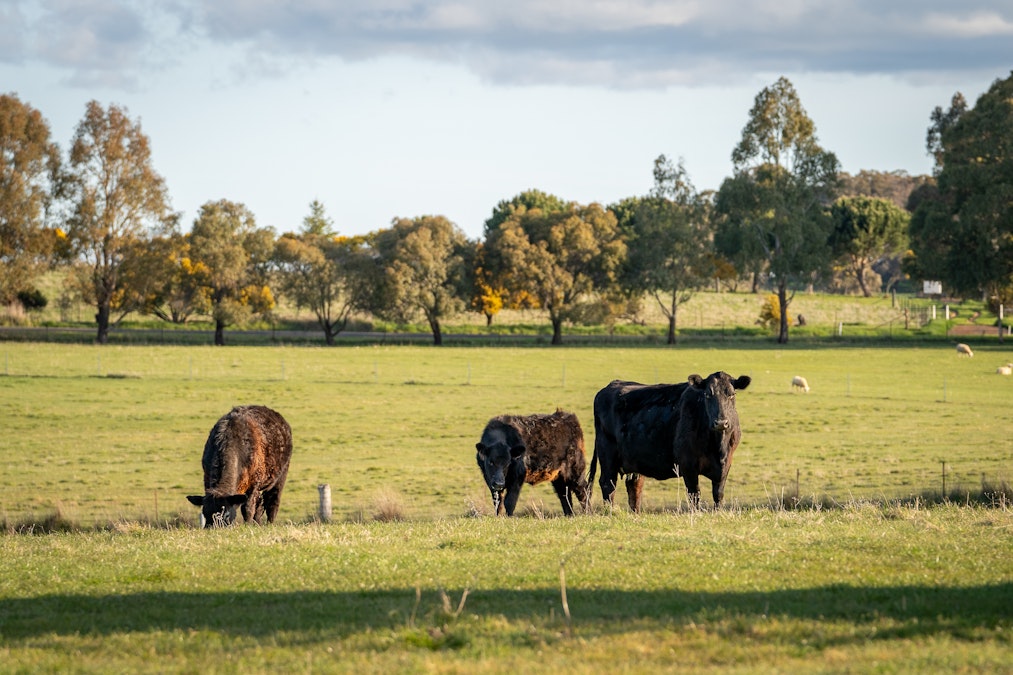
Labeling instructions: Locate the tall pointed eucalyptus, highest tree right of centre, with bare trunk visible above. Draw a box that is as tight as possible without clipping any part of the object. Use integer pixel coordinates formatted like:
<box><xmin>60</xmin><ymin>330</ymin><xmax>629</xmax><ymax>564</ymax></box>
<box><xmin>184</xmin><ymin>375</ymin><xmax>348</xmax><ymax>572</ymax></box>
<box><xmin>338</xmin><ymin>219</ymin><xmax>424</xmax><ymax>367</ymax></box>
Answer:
<box><xmin>716</xmin><ymin>77</ymin><xmax>840</xmax><ymax>344</ymax></box>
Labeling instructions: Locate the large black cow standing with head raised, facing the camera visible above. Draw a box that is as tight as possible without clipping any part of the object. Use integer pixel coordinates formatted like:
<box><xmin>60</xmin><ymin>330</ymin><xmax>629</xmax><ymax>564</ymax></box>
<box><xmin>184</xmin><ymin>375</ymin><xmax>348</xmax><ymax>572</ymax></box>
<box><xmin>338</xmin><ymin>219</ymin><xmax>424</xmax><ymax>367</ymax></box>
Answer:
<box><xmin>589</xmin><ymin>372</ymin><xmax>751</xmax><ymax>512</ymax></box>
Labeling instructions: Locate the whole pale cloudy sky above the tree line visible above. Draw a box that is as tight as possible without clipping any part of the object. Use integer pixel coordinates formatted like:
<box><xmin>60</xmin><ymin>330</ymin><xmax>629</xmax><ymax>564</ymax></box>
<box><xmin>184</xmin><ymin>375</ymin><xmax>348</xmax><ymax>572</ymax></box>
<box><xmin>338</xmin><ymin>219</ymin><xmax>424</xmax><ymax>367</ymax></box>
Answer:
<box><xmin>0</xmin><ymin>0</ymin><xmax>1013</xmax><ymax>238</ymax></box>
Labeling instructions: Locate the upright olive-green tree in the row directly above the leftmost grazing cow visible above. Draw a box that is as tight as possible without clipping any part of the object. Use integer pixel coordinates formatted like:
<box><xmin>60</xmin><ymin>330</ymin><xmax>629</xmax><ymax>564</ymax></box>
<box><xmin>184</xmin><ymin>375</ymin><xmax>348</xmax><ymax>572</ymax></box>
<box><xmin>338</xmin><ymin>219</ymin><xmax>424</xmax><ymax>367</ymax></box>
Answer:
<box><xmin>189</xmin><ymin>194</ymin><xmax>275</xmax><ymax>346</ymax></box>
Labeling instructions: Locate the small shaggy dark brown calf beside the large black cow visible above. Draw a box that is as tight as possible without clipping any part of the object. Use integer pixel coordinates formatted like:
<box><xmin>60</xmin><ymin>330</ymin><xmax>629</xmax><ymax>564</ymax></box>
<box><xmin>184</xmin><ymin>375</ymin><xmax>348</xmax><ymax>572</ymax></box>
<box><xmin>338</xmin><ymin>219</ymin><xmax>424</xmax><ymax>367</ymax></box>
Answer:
<box><xmin>475</xmin><ymin>410</ymin><xmax>590</xmax><ymax>516</ymax></box>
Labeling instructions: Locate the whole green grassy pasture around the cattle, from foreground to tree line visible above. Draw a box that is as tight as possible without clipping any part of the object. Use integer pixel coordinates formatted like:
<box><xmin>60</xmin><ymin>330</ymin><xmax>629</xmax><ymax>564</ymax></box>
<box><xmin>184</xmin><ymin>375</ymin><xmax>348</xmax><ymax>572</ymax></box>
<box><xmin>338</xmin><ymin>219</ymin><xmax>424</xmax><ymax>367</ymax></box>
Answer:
<box><xmin>0</xmin><ymin>343</ymin><xmax>1013</xmax><ymax>672</ymax></box>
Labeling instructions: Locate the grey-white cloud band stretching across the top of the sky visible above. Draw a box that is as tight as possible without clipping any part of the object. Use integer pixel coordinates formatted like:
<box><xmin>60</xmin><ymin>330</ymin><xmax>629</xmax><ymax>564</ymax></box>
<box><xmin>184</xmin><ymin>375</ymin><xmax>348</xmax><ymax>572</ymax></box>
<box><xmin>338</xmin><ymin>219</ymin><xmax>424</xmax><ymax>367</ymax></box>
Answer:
<box><xmin>7</xmin><ymin>0</ymin><xmax>1013</xmax><ymax>89</ymax></box>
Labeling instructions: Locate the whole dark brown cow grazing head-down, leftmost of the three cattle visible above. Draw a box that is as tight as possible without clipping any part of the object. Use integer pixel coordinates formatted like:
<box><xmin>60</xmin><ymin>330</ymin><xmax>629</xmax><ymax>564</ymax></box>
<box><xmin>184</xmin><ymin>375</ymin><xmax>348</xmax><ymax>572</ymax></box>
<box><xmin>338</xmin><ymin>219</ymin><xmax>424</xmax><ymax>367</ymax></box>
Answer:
<box><xmin>186</xmin><ymin>405</ymin><xmax>292</xmax><ymax>527</ymax></box>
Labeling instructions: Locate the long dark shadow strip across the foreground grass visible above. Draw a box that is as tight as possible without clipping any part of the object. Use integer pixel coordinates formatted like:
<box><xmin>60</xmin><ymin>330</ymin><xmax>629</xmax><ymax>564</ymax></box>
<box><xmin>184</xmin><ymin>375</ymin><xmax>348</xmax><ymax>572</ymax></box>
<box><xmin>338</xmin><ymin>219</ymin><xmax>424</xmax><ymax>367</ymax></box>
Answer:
<box><xmin>0</xmin><ymin>583</ymin><xmax>1013</xmax><ymax>646</ymax></box>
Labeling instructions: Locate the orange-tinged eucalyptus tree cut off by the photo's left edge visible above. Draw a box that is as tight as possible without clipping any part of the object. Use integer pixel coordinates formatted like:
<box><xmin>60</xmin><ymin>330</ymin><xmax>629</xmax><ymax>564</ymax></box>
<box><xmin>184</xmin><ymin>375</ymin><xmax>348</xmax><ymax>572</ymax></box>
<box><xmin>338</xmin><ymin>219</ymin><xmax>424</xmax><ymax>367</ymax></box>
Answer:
<box><xmin>0</xmin><ymin>94</ymin><xmax>61</xmax><ymax>304</ymax></box>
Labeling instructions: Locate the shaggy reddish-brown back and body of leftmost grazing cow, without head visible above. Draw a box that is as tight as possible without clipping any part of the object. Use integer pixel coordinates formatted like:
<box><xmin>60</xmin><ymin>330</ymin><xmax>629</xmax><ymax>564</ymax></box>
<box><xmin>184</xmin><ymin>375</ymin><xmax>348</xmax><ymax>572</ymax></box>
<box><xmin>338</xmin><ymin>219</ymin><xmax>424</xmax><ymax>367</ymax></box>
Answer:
<box><xmin>202</xmin><ymin>405</ymin><xmax>292</xmax><ymax>496</ymax></box>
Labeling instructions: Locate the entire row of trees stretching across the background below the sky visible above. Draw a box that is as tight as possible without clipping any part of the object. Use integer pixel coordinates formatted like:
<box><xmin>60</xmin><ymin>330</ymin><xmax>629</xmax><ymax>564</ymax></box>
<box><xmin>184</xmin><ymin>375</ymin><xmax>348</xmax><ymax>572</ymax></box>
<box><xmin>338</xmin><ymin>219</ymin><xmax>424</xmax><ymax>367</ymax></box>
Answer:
<box><xmin>0</xmin><ymin>75</ymin><xmax>1013</xmax><ymax>345</ymax></box>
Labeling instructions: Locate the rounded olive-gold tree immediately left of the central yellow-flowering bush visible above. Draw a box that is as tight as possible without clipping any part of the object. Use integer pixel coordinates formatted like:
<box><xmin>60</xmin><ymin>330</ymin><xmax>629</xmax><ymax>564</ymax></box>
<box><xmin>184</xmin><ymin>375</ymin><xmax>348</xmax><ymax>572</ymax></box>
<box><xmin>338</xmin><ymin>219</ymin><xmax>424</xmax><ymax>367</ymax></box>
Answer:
<box><xmin>372</xmin><ymin>216</ymin><xmax>475</xmax><ymax>346</ymax></box>
